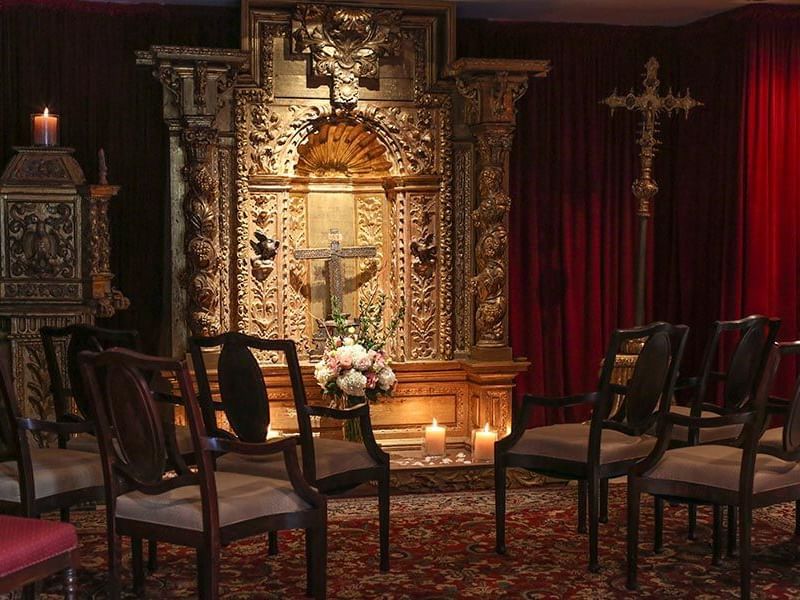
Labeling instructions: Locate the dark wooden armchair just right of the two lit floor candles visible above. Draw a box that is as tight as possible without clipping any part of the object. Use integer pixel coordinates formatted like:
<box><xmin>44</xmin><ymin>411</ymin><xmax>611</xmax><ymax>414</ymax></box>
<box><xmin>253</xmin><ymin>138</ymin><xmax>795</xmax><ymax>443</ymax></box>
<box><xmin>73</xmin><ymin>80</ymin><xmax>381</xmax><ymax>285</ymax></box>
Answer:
<box><xmin>494</xmin><ymin>323</ymin><xmax>688</xmax><ymax>571</ymax></box>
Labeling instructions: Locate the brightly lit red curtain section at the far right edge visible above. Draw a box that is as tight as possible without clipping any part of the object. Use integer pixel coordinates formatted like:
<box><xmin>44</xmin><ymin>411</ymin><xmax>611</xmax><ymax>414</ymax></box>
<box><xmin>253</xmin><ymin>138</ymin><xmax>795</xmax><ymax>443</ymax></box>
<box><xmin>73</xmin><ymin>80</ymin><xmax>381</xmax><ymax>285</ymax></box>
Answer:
<box><xmin>736</xmin><ymin>7</ymin><xmax>800</xmax><ymax>393</ymax></box>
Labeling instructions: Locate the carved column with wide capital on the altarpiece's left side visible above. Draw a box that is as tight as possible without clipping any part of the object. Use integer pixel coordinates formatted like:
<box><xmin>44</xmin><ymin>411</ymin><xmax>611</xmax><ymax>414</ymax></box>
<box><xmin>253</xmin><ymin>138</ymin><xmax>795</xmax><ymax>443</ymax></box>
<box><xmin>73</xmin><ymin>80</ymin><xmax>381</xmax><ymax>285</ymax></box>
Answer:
<box><xmin>137</xmin><ymin>46</ymin><xmax>247</xmax><ymax>344</ymax></box>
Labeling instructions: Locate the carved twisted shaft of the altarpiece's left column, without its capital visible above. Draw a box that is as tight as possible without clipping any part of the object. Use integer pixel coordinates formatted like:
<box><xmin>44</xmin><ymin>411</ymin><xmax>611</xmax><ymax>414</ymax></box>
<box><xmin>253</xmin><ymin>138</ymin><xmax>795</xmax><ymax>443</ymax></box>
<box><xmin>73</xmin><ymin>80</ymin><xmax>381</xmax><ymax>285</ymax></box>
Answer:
<box><xmin>181</xmin><ymin>125</ymin><xmax>220</xmax><ymax>336</ymax></box>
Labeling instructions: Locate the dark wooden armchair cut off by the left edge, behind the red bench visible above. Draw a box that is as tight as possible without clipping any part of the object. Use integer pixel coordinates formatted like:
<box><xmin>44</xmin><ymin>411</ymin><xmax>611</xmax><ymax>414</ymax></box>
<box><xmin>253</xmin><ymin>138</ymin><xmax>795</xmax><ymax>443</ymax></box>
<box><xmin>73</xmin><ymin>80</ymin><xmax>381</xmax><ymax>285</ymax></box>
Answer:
<box><xmin>0</xmin><ymin>352</ymin><xmax>104</xmax><ymax>599</ymax></box>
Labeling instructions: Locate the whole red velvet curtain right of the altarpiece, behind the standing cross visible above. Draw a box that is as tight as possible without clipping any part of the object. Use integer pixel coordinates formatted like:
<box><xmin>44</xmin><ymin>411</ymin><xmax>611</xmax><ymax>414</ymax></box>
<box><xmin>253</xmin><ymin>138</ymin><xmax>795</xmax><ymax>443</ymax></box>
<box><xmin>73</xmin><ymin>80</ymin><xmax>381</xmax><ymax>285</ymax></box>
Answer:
<box><xmin>459</xmin><ymin>7</ymin><xmax>800</xmax><ymax>424</ymax></box>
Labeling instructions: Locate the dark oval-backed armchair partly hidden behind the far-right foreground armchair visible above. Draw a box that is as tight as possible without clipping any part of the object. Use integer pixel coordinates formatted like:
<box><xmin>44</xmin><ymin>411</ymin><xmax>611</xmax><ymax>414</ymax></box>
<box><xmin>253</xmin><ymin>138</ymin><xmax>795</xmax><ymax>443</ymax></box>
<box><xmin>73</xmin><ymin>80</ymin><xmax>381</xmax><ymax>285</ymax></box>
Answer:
<box><xmin>654</xmin><ymin>315</ymin><xmax>781</xmax><ymax>548</ymax></box>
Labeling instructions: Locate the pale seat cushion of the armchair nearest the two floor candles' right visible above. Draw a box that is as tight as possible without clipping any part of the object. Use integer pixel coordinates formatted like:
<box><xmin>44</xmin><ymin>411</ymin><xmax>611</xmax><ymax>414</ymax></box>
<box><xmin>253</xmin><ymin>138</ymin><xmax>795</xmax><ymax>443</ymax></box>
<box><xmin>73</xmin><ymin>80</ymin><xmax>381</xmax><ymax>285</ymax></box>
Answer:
<box><xmin>509</xmin><ymin>423</ymin><xmax>656</xmax><ymax>464</ymax></box>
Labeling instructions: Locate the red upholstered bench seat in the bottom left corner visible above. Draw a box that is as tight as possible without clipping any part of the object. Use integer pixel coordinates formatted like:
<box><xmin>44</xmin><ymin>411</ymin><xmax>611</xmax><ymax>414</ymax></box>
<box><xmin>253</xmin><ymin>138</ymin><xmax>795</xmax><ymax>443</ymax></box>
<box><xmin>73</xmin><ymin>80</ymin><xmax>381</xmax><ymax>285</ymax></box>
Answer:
<box><xmin>0</xmin><ymin>515</ymin><xmax>78</xmax><ymax>599</ymax></box>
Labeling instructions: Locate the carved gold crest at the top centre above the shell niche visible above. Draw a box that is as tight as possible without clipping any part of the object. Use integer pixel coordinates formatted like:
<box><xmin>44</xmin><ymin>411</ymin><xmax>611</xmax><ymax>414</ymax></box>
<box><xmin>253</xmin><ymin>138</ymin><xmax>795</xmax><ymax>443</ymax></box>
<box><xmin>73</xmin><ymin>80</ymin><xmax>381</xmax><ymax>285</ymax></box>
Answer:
<box><xmin>292</xmin><ymin>4</ymin><xmax>401</xmax><ymax>106</ymax></box>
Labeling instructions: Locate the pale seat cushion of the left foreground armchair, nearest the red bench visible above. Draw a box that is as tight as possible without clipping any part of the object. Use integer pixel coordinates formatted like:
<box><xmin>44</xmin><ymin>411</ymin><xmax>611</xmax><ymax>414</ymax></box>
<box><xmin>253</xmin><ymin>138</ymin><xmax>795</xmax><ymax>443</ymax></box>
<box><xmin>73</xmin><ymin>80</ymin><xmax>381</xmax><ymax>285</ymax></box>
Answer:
<box><xmin>116</xmin><ymin>474</ymin><xmax>311</xmax><ymax>531</ymax></box>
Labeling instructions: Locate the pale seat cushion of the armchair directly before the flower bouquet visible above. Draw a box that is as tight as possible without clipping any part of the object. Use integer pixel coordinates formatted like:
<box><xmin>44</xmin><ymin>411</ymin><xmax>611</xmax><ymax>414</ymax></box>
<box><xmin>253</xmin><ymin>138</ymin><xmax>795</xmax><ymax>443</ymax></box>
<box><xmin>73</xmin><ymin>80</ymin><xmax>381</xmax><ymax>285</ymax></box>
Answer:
<box><xmin>217</xmin><ymin>438</ymin><xmax>380</xmax><ymax>479</ymax></box>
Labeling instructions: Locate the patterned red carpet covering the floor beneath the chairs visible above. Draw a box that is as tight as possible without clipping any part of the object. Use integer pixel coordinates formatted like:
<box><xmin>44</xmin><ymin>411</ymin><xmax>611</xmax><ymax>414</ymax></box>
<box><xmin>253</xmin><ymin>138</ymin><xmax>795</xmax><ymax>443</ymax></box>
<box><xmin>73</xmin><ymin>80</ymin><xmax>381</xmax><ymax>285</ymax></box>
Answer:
<box><xmin>18</xmin><ymin>485</ymin><xmax>800</xmax><ymax>600</ymax></box>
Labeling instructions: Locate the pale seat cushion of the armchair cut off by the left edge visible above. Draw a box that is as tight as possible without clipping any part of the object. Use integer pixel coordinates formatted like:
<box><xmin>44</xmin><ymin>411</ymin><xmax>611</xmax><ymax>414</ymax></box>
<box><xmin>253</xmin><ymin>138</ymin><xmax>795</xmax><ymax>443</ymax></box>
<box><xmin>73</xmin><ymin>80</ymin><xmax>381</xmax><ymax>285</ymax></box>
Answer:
<box><xmin>0</xmin><ymin>448</ymin><xmax>103</xmax><ymax>502</ymax></box>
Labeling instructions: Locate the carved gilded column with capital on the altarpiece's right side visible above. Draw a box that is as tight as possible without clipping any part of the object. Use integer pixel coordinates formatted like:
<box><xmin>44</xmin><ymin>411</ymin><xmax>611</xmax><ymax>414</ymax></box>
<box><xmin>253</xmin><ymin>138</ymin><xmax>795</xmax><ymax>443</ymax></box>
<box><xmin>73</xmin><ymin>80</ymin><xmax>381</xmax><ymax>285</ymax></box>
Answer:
<box><xmin>450</xmin><ymin>58</ymin><xmax>550</xmax><ymax>360</ymax></box>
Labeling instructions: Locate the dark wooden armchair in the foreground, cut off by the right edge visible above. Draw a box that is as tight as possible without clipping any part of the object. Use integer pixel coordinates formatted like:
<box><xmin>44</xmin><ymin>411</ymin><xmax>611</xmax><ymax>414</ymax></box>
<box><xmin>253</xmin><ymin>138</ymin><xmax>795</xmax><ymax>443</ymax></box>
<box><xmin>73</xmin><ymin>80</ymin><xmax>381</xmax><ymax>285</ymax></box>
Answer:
<box><xmin>627</xmin><ymin>342</ymin><xmax>800</xmax><ymax>599</ymax></box>
